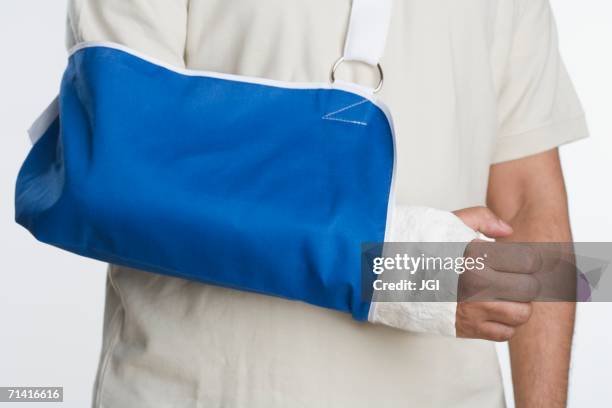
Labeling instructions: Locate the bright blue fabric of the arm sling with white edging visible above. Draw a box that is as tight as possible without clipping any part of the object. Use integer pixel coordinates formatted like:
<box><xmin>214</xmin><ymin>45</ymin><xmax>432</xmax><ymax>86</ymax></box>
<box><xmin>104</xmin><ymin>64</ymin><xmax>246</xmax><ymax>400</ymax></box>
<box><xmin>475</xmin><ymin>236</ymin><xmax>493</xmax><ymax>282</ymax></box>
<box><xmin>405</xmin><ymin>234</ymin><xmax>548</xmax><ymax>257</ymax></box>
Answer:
<box><xmin>16</xmin><ymin>47</ymin><xmax>394</xmax><ymax>320</ymax></box>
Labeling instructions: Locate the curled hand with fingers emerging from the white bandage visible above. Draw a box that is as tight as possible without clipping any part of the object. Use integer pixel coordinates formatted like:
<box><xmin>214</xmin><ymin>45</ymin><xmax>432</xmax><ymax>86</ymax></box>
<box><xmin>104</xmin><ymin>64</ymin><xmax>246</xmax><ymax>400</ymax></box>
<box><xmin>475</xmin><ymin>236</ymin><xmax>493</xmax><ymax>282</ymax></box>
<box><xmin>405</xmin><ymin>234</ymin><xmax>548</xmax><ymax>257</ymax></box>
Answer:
<box><xmin>455</xmin><ymin>207</ymin><xmax>541</xmax><ymax>341</ymax></box>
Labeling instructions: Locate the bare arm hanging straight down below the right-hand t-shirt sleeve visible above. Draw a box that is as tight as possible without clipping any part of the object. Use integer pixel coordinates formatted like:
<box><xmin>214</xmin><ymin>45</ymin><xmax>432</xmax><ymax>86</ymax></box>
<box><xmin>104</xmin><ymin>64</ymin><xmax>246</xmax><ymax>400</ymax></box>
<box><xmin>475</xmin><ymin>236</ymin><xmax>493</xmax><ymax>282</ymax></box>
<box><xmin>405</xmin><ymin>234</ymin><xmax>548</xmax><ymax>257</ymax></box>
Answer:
<box><xmin>488</xmin><ymin>149</ymin><xmax>575</xmax><ymax>408</ymax></box>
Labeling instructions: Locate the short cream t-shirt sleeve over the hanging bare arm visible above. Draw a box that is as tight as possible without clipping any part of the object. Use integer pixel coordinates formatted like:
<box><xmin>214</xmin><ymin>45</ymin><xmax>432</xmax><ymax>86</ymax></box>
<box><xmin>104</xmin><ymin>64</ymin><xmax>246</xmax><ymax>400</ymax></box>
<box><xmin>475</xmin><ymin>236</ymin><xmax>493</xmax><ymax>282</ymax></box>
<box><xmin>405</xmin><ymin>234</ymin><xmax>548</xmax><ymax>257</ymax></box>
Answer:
<box><xmin>492</xmin><ymin>0</ymin><xmax>588</xmax><ymax>163</ymax></box>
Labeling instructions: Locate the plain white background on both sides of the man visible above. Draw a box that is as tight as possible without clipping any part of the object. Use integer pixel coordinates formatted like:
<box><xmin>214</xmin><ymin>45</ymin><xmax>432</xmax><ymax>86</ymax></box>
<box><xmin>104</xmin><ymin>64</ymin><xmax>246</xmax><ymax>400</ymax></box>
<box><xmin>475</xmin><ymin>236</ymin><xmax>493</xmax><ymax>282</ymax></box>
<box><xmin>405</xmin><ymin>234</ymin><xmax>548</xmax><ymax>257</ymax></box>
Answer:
<box><xmin>0</xmin><ymin>0</ymin><xmax>612</xmax><ymax>408</ymax></box>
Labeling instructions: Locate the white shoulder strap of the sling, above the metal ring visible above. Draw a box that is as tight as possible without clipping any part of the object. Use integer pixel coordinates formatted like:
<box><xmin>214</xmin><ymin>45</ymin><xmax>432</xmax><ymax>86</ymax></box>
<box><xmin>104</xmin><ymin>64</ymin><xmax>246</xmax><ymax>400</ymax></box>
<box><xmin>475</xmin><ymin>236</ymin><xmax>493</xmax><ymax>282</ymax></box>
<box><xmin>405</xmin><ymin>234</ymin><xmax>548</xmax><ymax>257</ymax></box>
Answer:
<box><xmin>343</xmin><ymin>0</ymin><xmax>393</xmax><ymax>66</ymax></box>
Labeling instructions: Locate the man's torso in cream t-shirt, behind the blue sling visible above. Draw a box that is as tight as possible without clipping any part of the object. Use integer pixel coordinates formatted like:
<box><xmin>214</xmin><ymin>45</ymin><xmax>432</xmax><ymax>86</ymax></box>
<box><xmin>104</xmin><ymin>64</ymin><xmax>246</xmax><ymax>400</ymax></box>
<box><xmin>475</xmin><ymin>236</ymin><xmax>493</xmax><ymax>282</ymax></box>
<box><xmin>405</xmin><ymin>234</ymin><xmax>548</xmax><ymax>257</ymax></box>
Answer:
<box><xmin>71</xmin><ymin>0</ymin><xmax>514</xmax><ymax>407</ymax></box>
